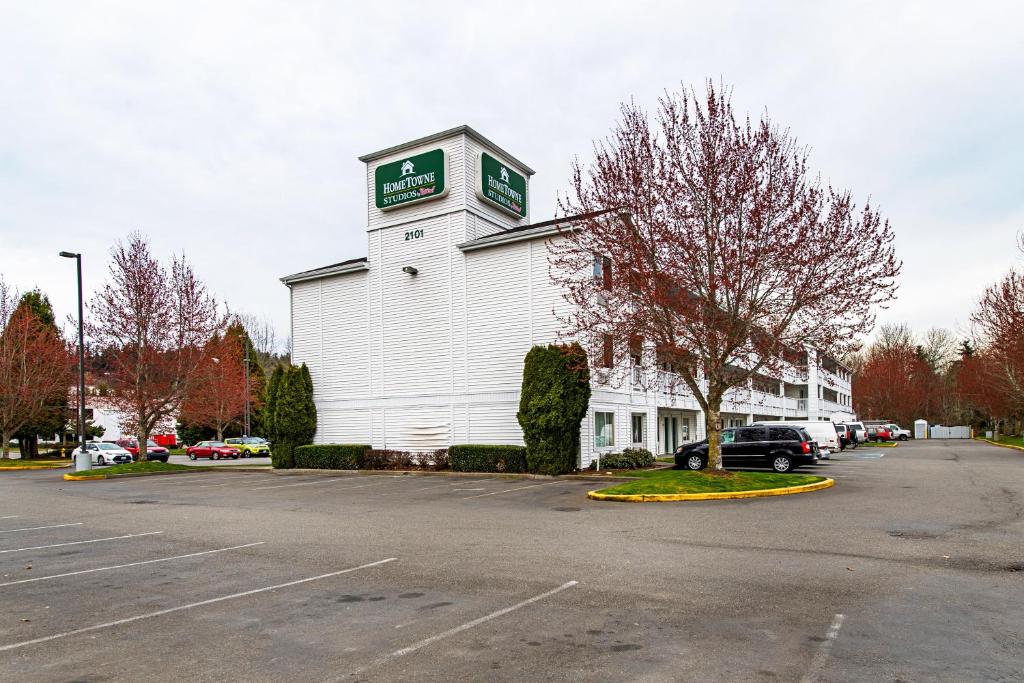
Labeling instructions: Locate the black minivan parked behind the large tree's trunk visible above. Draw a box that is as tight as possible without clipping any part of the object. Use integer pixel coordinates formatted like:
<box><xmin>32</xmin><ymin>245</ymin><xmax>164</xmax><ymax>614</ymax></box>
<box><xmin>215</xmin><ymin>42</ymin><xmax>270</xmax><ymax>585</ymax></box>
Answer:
<box><xmin>676</xmin><ymin>426</ymin><xmax>818</xmax><ymax>472</ymax></box>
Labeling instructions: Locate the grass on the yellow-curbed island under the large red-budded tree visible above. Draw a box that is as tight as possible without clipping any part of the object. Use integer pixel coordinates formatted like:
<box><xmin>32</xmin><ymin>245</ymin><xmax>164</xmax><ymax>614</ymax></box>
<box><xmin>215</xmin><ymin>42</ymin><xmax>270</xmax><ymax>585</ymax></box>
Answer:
<box><xmin>600</xmin><ymin>469</ymin><xmax>825</xmax><ymax>495</ymax></box>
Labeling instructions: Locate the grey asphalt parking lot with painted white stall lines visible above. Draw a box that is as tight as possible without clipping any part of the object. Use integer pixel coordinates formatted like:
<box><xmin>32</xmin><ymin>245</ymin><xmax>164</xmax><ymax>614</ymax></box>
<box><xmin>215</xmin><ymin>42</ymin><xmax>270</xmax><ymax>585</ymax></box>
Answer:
<box><xmin>0</xmin><ymin>441</ymin><xmax>1024</xmax><ymax>681</ymax></box>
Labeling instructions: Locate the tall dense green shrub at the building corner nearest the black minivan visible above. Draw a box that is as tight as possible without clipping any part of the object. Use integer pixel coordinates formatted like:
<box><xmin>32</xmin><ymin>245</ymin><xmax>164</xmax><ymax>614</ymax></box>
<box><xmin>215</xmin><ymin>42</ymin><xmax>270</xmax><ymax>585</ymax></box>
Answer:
<box><xmin>516</xmin><ymin>343</ymin><xmax>590</xmax><ymax>474</ymax></box>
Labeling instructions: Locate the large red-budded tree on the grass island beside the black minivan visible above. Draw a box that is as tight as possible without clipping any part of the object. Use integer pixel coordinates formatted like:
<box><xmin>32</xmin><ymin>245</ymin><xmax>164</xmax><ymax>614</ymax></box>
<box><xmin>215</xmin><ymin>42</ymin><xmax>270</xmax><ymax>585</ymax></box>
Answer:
<box><xmin>551</xmin><ymin>82</ymin><xmax>901</xmax><ymax>469</ymax></box>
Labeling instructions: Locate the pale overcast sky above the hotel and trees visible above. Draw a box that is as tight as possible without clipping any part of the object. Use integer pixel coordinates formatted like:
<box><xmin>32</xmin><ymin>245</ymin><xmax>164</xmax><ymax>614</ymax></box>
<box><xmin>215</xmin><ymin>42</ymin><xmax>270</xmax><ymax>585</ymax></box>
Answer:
<box><xmin>0</xmin><ymin>0</ymin><xmax>1024</xmax><ymax>352</ymax></box>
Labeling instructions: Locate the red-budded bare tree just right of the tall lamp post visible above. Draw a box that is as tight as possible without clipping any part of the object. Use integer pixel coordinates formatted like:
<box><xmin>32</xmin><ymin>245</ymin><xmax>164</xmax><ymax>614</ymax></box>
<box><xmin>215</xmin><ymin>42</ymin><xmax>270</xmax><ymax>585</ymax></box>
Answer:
<box><xmin>87</xmin><ymin>233</ymin><xmax>227</xmax><ymax>460</ymax></box>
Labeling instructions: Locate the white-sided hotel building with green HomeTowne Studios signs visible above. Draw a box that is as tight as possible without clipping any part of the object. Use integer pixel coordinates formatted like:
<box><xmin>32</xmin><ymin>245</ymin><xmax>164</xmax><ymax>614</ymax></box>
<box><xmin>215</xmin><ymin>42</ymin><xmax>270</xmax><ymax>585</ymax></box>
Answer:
<box><xmin>282</xmin><ymin>126</ymin><xmax>852</xmax><ymax>467</ymax></box>
